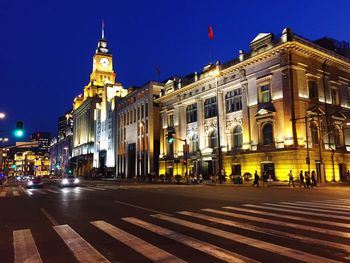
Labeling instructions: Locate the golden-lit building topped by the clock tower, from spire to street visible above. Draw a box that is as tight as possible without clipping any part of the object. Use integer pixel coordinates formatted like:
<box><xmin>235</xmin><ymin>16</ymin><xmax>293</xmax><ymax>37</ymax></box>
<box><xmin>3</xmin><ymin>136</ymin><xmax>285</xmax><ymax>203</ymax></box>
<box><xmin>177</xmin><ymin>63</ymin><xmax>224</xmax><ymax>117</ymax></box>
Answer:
<box><xmin>72</xmin><ymin>26</ymin><xmax>116</xmax><ymax>176</ymax></box>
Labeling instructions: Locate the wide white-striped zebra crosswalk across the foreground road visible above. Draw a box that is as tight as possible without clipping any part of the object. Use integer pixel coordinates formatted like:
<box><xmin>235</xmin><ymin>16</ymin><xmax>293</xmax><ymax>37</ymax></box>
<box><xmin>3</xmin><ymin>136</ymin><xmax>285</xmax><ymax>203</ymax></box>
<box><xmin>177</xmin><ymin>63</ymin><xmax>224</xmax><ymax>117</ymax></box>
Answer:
<box><xmin>0</xmin><ymin>199</ymin><xmax>350</xmax><ymax>263</ymax></box>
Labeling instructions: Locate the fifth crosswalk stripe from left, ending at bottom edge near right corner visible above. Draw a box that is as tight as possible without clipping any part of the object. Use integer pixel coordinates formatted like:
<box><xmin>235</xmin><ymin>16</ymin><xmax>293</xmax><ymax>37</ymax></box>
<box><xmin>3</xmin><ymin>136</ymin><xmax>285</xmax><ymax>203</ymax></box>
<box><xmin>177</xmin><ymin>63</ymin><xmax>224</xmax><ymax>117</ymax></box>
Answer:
<box><xmin>152</xmin><ymin>215</ymin><xmax>339</xmax><ymax>263</ymax></box>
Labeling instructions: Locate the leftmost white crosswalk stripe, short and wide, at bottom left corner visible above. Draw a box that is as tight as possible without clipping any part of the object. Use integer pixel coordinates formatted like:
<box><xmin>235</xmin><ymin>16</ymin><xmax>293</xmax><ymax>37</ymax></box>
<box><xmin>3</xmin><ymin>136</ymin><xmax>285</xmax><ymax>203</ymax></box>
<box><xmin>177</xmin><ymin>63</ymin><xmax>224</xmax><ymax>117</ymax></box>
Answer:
<box><xmin>13</xmin><ymin>229</ymin><xmax>42</xmax><ymax>263</ymax></box>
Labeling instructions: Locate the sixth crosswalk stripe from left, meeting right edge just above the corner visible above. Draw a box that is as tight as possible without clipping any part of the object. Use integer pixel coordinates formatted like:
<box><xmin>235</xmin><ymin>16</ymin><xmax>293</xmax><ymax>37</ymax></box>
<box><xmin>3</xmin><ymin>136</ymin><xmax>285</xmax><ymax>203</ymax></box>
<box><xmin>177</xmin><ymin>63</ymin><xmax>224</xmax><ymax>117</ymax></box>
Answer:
<box><xmin>178</xmin><ymin>211</ymin><xmax>350</xmax><ymax>254</ymax></box>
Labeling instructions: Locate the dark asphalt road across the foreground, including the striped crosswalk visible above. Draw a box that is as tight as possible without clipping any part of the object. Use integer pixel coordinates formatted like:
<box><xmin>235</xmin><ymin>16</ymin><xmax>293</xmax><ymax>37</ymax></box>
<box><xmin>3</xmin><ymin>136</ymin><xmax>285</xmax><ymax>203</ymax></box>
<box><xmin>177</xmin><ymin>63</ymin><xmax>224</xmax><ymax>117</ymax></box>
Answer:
<box><xmin>0</xmin><ymin>179</ymin><xmax>350</xmax><ymax>263</ymax></box>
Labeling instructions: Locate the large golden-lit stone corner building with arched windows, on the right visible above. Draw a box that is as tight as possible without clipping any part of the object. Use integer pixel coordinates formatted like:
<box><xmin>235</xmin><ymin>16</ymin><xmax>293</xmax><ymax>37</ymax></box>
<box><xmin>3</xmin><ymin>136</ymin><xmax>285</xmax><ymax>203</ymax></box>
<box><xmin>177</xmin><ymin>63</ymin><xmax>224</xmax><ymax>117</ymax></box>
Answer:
<box><xmin>155</xmin><ymin>28</ymin><xmax>350</xmax><ymax>182</ymax></box>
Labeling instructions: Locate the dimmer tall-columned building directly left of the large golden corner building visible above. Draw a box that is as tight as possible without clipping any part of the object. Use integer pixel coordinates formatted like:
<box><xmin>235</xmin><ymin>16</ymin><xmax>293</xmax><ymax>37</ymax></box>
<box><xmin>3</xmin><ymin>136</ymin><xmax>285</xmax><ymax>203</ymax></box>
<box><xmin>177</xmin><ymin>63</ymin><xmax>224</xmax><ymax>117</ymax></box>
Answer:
<box><xmin>115</xmin><ymin>81</ymin><xmax>164</xmax><ymax>179</ymax></box>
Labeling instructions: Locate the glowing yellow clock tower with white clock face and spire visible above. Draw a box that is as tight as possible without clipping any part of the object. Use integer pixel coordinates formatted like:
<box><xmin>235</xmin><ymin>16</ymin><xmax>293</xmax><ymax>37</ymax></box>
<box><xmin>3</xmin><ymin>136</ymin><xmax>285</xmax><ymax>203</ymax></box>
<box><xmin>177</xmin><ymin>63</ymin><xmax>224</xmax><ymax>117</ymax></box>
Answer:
<box><xmin>84</xmin><ymin>24</ymin><xmax>116</xmax><ymax>98</ymax></box>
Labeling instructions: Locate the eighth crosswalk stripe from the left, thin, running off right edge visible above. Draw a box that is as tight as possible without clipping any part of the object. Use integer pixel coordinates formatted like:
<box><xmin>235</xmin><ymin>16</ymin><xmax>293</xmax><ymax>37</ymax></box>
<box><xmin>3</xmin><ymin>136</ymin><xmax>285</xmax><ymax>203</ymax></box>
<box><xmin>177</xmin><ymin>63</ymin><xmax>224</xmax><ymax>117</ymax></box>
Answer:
<box><xmin>216</xmin><ymin>207</ymin><xmax>350</xmax><ymax>228</ymax></box>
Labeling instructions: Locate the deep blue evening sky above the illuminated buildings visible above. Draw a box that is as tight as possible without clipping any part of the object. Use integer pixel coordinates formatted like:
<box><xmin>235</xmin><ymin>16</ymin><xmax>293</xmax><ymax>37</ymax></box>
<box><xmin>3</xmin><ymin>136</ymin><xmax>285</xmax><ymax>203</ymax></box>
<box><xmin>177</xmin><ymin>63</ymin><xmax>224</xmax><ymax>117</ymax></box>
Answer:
<box><xmin>0</xmin><ymin>0</ymin><xmax>350</xmax><ymax>142</ymax></box>
